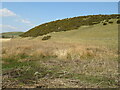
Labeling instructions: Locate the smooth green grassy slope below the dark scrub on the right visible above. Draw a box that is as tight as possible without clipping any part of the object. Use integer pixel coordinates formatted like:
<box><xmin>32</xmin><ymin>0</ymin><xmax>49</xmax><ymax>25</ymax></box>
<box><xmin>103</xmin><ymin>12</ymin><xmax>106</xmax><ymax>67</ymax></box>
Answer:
<box><xmin>33</xmin><ymin>20</ymin><xmax>118</xmax><ymax>48</ymax></box>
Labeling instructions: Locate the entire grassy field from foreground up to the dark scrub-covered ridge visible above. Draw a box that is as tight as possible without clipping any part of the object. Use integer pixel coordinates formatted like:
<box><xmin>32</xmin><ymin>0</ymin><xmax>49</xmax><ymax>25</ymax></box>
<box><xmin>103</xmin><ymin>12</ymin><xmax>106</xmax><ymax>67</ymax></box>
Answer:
<box><xmin>2</xmin><ymin>20</ymin><xmax>118</xmax><ymax>88</ymax></box>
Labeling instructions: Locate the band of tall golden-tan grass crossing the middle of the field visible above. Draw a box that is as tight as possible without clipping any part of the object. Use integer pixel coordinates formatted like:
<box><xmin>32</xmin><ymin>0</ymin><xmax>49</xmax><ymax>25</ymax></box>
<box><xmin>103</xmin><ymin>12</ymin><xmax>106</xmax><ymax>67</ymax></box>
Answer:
<box><xmin>2</xmin><ymin>39</ymin><xmax>118</xmax><ymax>60</ymax></box>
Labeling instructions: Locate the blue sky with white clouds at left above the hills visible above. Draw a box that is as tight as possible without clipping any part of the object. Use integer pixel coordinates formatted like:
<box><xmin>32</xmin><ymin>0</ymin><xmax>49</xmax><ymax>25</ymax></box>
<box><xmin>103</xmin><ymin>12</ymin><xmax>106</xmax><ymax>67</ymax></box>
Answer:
<box><xmin>0</xmin><ymin>2</ymin><xmax>118</xmax><ymax>33</ymax></box>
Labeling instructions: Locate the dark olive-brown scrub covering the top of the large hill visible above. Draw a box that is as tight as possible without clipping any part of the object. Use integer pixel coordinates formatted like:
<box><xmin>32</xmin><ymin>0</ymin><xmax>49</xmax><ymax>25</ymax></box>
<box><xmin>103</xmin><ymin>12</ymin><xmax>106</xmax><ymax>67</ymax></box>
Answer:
<box><xmin>20</xmin><ymin>14</ymin><xmax>120</xmax><ymax>37</ymax></box>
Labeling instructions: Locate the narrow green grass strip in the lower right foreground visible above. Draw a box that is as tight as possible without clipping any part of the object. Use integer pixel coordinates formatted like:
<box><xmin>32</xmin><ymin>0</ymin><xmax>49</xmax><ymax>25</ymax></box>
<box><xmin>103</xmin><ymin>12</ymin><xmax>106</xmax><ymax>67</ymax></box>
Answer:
<box><xmin>61</xmin><ymin>73</ymin><xmax>118</xmax><ymax>87</ymax></box>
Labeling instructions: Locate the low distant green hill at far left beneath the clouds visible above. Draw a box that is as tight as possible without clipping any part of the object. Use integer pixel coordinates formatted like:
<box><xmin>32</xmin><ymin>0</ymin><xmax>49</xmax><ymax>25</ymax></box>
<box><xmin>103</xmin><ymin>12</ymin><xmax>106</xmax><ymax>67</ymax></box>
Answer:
<box><xmin>0</xmin><ymin>32</ymin><xmax>24</xmax><ymax>38</ymax></box>
